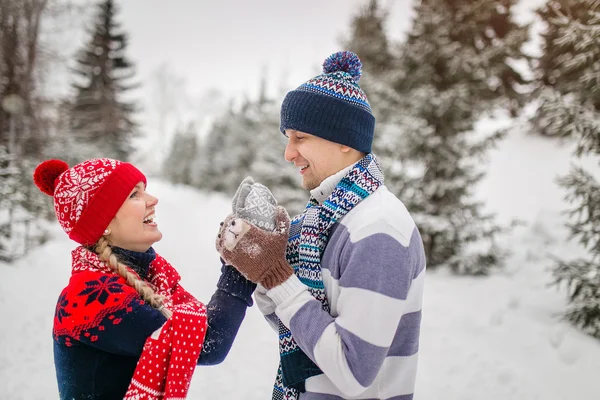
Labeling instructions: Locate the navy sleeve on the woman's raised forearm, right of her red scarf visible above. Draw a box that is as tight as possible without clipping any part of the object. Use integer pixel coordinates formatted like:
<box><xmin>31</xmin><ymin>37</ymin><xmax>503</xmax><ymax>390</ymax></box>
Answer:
<box><xmin>198</xmin><ymin>263</ymin><xmax>256</xmax><ymax>365</ymax></box>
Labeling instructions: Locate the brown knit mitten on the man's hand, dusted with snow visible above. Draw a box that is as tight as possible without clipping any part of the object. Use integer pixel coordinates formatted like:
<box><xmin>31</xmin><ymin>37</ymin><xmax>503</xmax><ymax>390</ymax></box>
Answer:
<box><xmin>215</xmin><ymin>206</ymin><xmax>294</xmax><ymax>289</ymax></box>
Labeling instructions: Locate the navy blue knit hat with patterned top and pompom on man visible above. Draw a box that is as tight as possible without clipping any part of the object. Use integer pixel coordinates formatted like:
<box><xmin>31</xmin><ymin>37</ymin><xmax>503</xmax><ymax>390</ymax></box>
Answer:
<box><xmin>279</xmin><ymin>51</ymin><xmax>375</xmax><ymax>153</ymax></box>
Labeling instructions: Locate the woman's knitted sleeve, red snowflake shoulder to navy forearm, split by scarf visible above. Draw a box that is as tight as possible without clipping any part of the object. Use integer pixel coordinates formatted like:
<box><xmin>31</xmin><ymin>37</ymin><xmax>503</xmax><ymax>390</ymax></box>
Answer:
<box><xmin>54</xmin><ymin>265</ymin><xmax>256</xmax><ymax>365</ymax></box>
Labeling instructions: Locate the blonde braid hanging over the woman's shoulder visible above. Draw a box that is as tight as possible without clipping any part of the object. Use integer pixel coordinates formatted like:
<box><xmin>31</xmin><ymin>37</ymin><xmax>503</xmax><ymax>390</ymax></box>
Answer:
<box><xmin>95</xmin><ymin>236</ymin><xmax>173</xmax><ymax>318</ymax></box>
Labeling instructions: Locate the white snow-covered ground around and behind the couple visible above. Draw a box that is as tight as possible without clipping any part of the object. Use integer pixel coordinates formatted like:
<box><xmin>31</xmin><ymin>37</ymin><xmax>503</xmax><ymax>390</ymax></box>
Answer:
<box><xmin>0</xmin><ymin>122</ymin><xmax>600</xmax><ymax>400</ymax></box>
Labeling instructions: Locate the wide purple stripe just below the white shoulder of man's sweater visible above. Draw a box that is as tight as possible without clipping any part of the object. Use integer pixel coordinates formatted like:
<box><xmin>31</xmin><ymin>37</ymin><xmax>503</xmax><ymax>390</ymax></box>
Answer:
<box><xmin>321</xmin><ymin>224</ymin><xmax>425</xmax><ymax>300</ymax></box>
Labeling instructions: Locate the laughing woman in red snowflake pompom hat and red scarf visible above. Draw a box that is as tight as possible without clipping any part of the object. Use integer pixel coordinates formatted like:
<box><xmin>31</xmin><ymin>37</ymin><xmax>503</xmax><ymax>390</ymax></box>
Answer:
<box><xmin>34</xmin><ymin>158</ymin><xmax>256</xmax><ymax>400</ymax></box>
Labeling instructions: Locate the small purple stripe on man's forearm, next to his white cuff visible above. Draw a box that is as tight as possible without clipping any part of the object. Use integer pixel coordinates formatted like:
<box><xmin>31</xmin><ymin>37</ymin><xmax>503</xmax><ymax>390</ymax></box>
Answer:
<box><xmin>289</xmin><ymin>300</ymin><xmax>334</xmax><ymax>362</ymax></box>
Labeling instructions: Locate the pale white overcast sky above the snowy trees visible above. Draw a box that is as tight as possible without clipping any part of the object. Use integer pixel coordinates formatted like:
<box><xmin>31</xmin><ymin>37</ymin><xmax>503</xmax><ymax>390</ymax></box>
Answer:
<box><xmin>45</xmin><ymin>0</ymin><xmax>543</xmax><ymax>159</ymax></box>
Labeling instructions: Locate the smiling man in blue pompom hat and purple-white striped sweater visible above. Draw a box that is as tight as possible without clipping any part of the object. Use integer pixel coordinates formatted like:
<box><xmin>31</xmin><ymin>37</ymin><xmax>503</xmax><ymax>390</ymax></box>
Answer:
<box><xmin>217</xmin><ymin>52</ymin><xmax>425</xmax><ymax>400</ymax></box>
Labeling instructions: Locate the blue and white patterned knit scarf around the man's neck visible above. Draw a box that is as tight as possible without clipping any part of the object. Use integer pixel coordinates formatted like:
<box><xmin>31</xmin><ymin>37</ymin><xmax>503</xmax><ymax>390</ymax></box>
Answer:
<box><xmin>273</xmin><ymin>153</ymin><xmax>383</xmax><ymax>400</ymax></box>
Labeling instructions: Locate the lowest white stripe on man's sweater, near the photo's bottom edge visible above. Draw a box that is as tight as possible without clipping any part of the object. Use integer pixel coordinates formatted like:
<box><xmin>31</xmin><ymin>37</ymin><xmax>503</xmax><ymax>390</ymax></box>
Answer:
<box><xmin>306</xmin><ymin>354</ymin><xmax>418</xmax><ymax>399</ymax></box>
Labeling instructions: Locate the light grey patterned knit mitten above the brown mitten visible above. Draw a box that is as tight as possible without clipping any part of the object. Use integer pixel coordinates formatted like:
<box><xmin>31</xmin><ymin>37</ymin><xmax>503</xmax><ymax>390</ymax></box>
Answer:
<box><xmin>231</xmin><ymin>176</ymin><xmax>277</xmax><ymax>232</ymax></box>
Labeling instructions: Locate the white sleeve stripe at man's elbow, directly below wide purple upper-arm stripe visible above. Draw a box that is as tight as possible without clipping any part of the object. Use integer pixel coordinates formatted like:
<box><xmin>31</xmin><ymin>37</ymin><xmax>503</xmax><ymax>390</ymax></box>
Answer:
<box><xmin>336</xmin><ymin>270</ymin><xmax>425</xmax><ymax>347</ymax></box>
